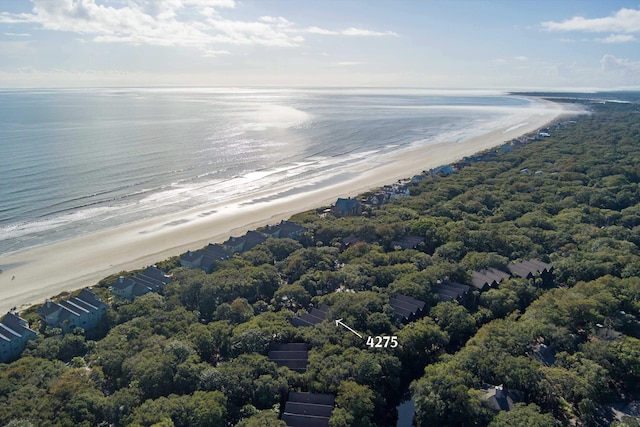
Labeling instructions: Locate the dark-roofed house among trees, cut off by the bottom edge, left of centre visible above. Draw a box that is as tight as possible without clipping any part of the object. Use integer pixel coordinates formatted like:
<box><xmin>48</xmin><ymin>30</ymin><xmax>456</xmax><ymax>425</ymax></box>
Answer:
<box><xmin>282</xmin><ymin>391</ymin><xmax>335</xmax><ymax>427</ymax></box>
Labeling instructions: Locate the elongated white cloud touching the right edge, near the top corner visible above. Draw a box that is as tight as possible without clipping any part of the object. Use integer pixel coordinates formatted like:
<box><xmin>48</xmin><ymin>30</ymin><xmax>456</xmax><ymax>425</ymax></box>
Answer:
<box><xmin>542</xmin><ymin>8</ymin><xmax>640</xmax><ymax>34</ymax></box>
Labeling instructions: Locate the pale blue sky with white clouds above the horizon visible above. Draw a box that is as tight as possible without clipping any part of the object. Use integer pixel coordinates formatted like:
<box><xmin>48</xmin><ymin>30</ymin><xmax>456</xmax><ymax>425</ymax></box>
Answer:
<box><xmin>0</xmin><ymin>0</ymin><xmax>640</xmax><ymax>90</ymax></box>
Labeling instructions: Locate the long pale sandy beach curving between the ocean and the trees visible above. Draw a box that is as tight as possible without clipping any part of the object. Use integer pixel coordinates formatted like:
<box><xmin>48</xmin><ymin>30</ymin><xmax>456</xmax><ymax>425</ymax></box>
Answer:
<box><xmin>0</xmin><ymin>101</ymin><xmax>570</xmax><ymax>313</ymax></box>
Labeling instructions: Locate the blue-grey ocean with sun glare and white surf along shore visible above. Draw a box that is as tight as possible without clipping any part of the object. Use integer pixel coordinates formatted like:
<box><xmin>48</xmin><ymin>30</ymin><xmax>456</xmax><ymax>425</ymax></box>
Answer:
<box><xmin>0</xmin><ymin>88</ymin><xmax>541</xmax><ymax>254</ymax></box>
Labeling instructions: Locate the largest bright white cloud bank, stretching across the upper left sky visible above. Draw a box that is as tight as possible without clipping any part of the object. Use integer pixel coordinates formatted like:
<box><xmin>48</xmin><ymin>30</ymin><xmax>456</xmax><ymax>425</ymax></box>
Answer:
<box><xmin>0</xmin><ymin>0</ymin><xmax>397</xmax><ymax>56</ymax></box>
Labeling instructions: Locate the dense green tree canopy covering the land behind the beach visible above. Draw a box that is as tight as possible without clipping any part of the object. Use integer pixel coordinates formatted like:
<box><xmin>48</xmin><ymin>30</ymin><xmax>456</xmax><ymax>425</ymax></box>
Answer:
<box><xmin>0</xmin><ymin>95</ymin><xmax>640</xmax><ymax>427</ymax></box>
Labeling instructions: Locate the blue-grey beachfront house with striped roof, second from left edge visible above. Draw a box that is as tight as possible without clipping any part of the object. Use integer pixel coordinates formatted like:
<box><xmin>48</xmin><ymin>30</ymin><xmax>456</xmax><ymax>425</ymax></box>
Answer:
<box><xmin>37</xmin><ymin>289</ymin><xmax>107</xmax><ymax>334</ymax></box>
